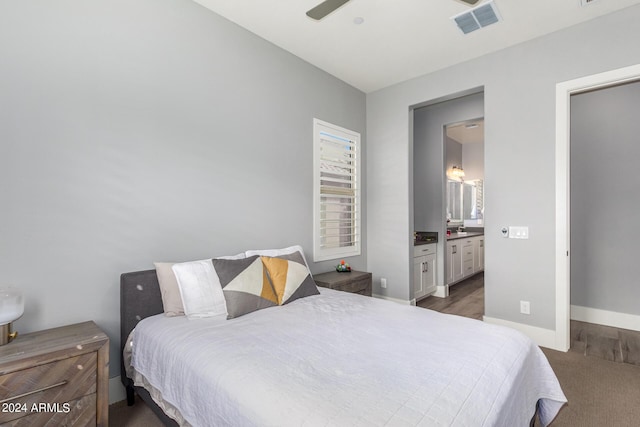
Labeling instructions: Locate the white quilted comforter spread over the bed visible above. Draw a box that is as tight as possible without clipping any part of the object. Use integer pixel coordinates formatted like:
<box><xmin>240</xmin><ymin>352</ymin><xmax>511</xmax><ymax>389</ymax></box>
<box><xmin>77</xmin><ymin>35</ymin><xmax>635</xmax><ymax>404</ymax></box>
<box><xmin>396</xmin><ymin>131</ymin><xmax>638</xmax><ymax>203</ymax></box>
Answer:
<box><xmin>132</xmin><ymin>288</ymin><xmax>566</xmax><ymax>427</ymax></box>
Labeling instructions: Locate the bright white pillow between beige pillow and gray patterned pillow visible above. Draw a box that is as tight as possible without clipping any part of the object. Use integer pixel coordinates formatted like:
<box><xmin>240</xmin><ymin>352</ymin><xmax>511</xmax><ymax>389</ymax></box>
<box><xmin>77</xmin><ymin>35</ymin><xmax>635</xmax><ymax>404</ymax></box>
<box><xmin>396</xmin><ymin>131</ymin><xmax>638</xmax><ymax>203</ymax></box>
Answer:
<box><xmin>171</xmin><ymin>259</ymin><xmax>227</xmax><ymax>319</ymax></box>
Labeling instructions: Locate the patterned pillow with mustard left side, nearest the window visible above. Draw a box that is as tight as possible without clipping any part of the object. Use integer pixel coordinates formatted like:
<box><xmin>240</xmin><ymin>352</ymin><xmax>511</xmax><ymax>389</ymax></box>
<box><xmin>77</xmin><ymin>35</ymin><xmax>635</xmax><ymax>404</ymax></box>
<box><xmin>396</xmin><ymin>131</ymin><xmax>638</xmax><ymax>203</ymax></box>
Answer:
<box><xmin>262</xmin><ymin>252</ymin><xmax>320</xmax><ymax>305</ymax></box>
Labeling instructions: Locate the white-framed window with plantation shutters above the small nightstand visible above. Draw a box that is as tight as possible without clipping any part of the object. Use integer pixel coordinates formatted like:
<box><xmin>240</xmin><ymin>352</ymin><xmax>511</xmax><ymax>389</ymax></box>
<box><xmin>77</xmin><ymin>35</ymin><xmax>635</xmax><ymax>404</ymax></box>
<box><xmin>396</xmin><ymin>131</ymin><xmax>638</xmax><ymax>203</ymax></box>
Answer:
<box><xmin>313</xmin><ymin>119</ymin><xmax>361</xmax><ymax>261</ymax></box>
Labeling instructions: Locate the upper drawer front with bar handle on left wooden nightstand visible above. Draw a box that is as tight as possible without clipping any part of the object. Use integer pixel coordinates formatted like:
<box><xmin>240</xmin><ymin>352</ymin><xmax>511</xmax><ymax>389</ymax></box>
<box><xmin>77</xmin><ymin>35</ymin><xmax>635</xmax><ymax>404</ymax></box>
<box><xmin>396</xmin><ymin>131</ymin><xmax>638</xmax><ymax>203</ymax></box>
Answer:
<box><xmin>0</xmin><ymin>352</ymin><xmax>97</xmax><ymax>425</ymax></box>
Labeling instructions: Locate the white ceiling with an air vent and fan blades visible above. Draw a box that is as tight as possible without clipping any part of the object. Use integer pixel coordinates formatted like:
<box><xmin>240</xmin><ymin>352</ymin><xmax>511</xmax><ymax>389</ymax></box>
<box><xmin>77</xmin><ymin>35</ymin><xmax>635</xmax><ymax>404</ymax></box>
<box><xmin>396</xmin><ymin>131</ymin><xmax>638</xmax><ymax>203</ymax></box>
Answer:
<box><xmin>194</xmin><ymin>0</ymin><xmax>640</xmax><ymax>93</ymax></box>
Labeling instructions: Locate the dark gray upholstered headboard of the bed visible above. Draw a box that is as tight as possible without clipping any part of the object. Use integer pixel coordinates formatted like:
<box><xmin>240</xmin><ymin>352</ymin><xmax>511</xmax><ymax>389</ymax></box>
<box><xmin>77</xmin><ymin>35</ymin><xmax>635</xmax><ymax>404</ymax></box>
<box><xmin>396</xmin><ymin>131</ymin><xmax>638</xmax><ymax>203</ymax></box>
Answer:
<box><xmin>120</xmin><ymin>270</ymin><xmax>164</xmax><ymax>392</ymax></box>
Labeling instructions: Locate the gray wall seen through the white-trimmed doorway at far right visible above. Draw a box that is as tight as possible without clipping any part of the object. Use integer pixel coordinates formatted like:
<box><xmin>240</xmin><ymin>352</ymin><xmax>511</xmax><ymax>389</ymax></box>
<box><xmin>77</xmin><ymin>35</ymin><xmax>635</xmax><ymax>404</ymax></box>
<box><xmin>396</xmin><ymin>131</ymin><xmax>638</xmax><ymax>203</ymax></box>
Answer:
<box><xmin>570</xmin><ymin>82</ymin><xmax>640</xmax><ymax>315</ymax></box>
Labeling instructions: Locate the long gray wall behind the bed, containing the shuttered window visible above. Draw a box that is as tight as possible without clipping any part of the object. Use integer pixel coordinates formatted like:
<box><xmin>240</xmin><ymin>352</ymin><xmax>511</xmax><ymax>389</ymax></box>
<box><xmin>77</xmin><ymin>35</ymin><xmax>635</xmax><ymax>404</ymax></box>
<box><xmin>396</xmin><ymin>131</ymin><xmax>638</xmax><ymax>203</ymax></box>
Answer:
<box><xmin>0</xmin><ymin>0</ymin><xmax>366</xmax><ymax>382</ymax></box>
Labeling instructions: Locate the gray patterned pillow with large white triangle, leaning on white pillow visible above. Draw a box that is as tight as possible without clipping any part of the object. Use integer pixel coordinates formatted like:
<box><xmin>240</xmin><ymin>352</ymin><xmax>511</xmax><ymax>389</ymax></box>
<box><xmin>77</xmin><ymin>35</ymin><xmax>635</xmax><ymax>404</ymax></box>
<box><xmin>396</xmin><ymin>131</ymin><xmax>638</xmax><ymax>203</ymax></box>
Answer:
<box><xmin>213</xmin><ymin>255</ymin><xmax>278</xmax><ymax>319</ymax></box>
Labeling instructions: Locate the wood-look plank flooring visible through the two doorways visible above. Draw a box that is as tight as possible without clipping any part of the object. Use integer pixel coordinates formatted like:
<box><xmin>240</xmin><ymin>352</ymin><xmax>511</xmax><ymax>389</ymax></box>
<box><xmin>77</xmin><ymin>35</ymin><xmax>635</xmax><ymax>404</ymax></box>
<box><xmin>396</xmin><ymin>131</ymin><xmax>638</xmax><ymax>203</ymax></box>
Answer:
<box><xmin>416</xmin><ymin>273</ymin><xmax>640</xmax><ymax>366</ymax></box>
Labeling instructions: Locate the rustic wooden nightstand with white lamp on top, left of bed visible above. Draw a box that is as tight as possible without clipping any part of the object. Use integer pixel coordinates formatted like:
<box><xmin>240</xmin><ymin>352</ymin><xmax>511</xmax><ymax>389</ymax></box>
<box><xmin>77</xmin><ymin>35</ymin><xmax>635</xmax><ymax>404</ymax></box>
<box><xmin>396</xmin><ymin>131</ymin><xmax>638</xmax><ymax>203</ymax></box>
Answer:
<box><xmin>0</xmin><ymin>322</ymin><xmax>109</xmax><ymax>427</ymax></box>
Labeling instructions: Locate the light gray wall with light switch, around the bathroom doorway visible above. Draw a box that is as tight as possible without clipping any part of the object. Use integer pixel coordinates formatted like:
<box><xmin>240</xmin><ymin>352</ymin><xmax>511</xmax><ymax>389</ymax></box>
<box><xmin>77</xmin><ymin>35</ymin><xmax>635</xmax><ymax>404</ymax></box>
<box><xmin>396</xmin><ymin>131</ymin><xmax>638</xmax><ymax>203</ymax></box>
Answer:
<box><xmin>367</xmin><ymin>6</ymin><xmax>640</xmax><ymax>330</ymax></box>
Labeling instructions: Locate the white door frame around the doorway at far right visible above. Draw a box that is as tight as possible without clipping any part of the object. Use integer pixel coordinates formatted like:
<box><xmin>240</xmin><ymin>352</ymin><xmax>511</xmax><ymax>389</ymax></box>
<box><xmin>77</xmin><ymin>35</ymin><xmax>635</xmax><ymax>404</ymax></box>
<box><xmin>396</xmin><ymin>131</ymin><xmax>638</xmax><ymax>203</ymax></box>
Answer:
<box><xmin>555</xmin><ymin>64</ymin><xmax>640</xmax><ymax>351</ymax></box>
